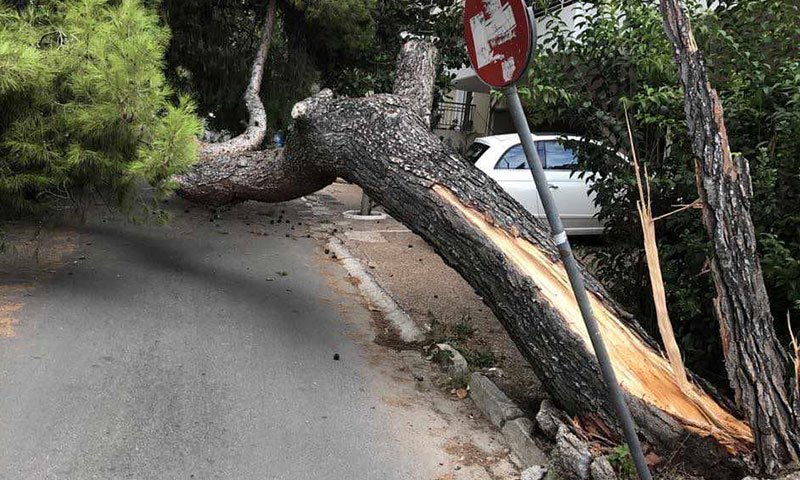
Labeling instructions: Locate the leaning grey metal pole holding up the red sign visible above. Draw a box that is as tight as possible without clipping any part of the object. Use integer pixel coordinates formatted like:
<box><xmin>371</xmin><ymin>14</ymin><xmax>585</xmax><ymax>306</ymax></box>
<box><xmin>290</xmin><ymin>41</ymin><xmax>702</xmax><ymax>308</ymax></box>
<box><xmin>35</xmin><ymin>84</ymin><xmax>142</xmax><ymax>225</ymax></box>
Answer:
<box><xmin>505</xmin><ymin>85</ymin><xmax>653</xmax><ymax>480</ymax></box>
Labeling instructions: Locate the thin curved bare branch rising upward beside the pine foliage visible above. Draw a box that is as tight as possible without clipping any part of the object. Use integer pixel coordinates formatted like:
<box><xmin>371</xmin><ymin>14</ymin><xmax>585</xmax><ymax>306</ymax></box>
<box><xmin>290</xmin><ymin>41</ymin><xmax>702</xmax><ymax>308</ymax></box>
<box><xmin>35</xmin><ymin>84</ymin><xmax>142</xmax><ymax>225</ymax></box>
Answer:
<box><xmin>200</xmin><ymin>0</ymin><xmax>276</xmax><ymax>158</ymax></box>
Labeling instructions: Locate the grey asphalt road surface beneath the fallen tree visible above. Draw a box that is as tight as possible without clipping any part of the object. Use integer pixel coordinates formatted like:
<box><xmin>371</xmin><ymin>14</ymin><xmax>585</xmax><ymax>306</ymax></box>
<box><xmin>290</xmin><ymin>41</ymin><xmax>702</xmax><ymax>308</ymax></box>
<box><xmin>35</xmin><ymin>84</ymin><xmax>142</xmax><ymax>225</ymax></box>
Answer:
<box><xmin>0</xmin><ymin>197</ymin><xmax>476</xmax><ymax>480</ymax></box>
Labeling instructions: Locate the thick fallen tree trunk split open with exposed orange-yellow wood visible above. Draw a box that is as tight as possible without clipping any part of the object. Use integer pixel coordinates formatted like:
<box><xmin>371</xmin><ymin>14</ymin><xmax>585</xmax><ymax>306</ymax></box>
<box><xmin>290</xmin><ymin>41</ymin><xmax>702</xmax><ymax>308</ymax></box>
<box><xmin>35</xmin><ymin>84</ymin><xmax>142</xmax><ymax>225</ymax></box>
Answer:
<box><xmin>178</xmin><ymin>44</ymin><xmax>753</xmax><ymax>478</ymax></box>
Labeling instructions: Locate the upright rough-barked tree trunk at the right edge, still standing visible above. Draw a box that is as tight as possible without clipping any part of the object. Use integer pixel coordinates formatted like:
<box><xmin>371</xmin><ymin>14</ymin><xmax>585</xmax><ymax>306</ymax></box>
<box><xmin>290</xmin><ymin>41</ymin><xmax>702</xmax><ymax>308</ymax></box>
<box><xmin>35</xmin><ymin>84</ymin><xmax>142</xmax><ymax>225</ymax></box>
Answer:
<box><xmin>661</xmin><ymin>0</ymin><xmax>800</xmax><ymax>473</ymax></box>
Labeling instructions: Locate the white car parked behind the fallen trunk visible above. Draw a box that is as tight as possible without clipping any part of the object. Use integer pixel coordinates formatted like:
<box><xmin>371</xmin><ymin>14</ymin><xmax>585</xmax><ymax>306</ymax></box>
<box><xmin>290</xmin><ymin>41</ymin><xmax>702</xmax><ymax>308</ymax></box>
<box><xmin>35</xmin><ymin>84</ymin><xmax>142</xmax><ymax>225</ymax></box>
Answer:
<box><xmin>466</xmin><ymin>134</ymin><xmax>603</xmax><ymax>235</ymax></box>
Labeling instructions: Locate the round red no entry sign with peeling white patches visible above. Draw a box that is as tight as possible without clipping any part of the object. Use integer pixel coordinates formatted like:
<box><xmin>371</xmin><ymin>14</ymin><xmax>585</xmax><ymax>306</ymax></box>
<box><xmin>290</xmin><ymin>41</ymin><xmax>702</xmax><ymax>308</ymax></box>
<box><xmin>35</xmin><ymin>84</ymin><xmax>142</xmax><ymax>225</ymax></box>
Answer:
<box><xmin>464</xmin><ymin>0</ymin><xmax>533</xmax><ymax>88</ymax></box>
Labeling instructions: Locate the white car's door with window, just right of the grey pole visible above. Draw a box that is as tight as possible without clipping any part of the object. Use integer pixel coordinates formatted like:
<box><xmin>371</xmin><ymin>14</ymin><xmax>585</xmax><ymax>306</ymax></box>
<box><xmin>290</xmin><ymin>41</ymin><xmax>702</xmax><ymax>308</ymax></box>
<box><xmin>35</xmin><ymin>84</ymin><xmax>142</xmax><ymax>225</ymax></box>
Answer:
<box><xmin>541</xmin><ymin>140</ymin><xmax>602</xmax><ymax>234</ymax></box>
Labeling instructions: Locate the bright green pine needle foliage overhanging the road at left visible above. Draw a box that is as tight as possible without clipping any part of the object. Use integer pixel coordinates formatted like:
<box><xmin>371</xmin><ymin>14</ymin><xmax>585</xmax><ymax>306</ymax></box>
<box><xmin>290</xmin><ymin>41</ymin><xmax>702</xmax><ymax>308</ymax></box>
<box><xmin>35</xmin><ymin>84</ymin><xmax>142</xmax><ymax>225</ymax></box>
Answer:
<box><xmin>0</xmin><ymin>0</ymin><xmax>201</xmax><ymax>216</ymax></box>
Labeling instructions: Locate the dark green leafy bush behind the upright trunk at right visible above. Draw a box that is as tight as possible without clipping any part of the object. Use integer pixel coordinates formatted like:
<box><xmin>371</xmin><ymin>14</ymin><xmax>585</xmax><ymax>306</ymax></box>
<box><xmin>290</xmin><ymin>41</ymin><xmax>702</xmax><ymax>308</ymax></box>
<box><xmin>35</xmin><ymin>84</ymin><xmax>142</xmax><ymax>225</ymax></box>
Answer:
<box><xmin>525</xmin><ymin>0</ymin><xmax>800</xmax><ymax>384</ymax></box>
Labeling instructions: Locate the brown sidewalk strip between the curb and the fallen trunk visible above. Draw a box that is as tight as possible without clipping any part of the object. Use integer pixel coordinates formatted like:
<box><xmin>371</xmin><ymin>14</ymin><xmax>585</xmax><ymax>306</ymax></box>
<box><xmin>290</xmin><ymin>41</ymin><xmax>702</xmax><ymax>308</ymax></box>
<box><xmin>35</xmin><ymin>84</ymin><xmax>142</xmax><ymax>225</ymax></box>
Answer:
<box><xmin>315</xmin><ymin>183</ymin><xmax>546</xmax><ymax>416</ymax></box>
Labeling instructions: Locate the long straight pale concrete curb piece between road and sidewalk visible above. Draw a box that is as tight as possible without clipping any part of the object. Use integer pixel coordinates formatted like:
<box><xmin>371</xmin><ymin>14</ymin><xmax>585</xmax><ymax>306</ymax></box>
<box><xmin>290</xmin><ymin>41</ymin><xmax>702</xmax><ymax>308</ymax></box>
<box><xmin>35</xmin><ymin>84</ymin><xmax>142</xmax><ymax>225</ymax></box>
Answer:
<box><xmin>327</xmin><ymin>237</ymin><xmax>425</xmax><ymax>343</ymax></box>
